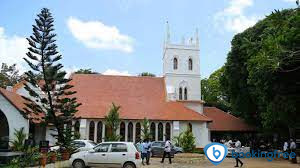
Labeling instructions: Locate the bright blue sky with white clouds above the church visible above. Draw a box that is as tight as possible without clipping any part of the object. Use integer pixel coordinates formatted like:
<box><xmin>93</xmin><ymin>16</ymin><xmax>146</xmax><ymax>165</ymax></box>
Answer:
<box><xmin>0</xmin><ymin>0</ymin><xmax>296</xmax><ymax>78</ymax></box>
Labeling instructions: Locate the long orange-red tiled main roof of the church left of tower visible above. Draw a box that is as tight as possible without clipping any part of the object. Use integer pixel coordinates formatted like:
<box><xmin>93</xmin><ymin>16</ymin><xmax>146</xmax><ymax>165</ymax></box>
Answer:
<box><xmin>70</xmin><ymin>74</ymin><xmax>211</xmax><ymax>121</ymax></box>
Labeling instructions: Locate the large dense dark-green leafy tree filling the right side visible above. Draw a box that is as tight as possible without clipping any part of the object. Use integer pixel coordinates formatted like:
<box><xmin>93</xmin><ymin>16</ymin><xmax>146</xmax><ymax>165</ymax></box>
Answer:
<box><xmin>221</xmin><ymin>8</ymin><xmax>300</xmax><ymax>136</ymax></box>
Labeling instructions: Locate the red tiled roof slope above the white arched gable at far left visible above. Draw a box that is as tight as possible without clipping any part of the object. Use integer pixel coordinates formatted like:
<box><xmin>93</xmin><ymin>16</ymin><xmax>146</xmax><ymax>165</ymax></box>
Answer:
<box><xmin>0</xmin><ymin>88</ymin><xmax>42</xmax><ymax>123</ymax></box>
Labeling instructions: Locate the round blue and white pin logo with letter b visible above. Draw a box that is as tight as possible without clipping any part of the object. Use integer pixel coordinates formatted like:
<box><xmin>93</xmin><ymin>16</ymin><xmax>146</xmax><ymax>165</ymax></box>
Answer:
<box><xmin>204</xmin><ymin>143</ymin><xmax>228</xmax><ymax>165</ymax></box>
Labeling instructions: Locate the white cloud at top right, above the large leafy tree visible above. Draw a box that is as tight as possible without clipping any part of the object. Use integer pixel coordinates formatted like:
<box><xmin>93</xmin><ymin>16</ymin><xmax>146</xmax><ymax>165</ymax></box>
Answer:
<box><xmin>214</xmin><ymin>0</ymin><xmax>260</xmax><ymax>33</ymax></box>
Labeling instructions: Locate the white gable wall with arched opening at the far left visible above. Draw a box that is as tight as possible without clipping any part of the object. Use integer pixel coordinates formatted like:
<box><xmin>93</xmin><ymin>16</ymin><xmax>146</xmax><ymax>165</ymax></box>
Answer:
<box><xmin>0</xmin><ymin>94</ymin><xmax>29</xmax><ymax>145</ymax></box>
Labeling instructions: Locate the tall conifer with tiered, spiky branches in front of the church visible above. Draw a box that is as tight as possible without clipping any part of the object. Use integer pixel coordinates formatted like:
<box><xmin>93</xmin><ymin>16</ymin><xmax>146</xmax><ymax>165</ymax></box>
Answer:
<box><xmin>24</xmin><ymin>8</ymin><xmax>80</xmax><ymax>148</ymax></box>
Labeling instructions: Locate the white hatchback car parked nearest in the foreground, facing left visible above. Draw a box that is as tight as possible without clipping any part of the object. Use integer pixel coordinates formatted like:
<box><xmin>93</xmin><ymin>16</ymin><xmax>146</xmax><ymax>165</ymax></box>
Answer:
<box><xmin>69</xmin><ymin>142</ymin><xmax>142</xmax><ymax>168</ymax></box>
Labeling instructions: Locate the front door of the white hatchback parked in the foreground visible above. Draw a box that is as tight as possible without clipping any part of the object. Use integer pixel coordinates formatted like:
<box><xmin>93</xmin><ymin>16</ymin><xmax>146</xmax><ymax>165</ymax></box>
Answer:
<box><xmin>86</xmin><ymin>143</ymin><xmax>111</xmax><ymax>167</ymax></box>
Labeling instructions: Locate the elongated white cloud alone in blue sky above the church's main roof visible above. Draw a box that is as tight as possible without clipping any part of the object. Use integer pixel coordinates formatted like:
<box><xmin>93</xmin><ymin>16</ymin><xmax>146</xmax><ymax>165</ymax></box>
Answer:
<box><xmin>67</xmin><ymin>17</ymin><xmax>134</xmax><ymax>53</ymax></box>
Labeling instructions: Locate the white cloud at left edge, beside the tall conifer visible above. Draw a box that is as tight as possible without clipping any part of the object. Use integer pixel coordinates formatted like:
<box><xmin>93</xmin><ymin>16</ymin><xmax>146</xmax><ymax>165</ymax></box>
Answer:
<box><xmin>0</xmin><ymin>27</ymin><xmax>29</xmax><ymax>73</ymax></box>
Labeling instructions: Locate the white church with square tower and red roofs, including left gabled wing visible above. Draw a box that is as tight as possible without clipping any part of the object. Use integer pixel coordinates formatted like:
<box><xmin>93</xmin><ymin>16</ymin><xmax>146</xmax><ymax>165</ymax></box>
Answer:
<box><xmin>0</xmin><ymin>28</ymin><xmax>253</xmax><ymax>148</ymax></box>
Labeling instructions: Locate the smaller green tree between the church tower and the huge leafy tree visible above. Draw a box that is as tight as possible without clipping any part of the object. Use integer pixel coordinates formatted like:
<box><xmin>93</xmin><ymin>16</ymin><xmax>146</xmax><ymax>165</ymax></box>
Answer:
<box><xmin>201</xmin><ymin>67</ymin><xmax>230</xmax><ymax>111</ymax></box>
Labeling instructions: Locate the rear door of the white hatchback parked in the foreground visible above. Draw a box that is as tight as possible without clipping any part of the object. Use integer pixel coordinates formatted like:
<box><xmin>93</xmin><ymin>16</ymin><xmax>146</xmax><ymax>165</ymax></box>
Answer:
<box><xmin>107</xmin><ymin>143</ymin><xmax>128</xmax><ymax>167</ymax></box>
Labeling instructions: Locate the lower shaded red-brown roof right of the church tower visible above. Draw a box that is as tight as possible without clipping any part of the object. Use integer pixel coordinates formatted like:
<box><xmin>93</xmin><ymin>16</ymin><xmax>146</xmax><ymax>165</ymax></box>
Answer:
<box><xmin>204</xmin><ymin>107</ymin><xmax>255</xmax><ymax>131</ymax></box>
